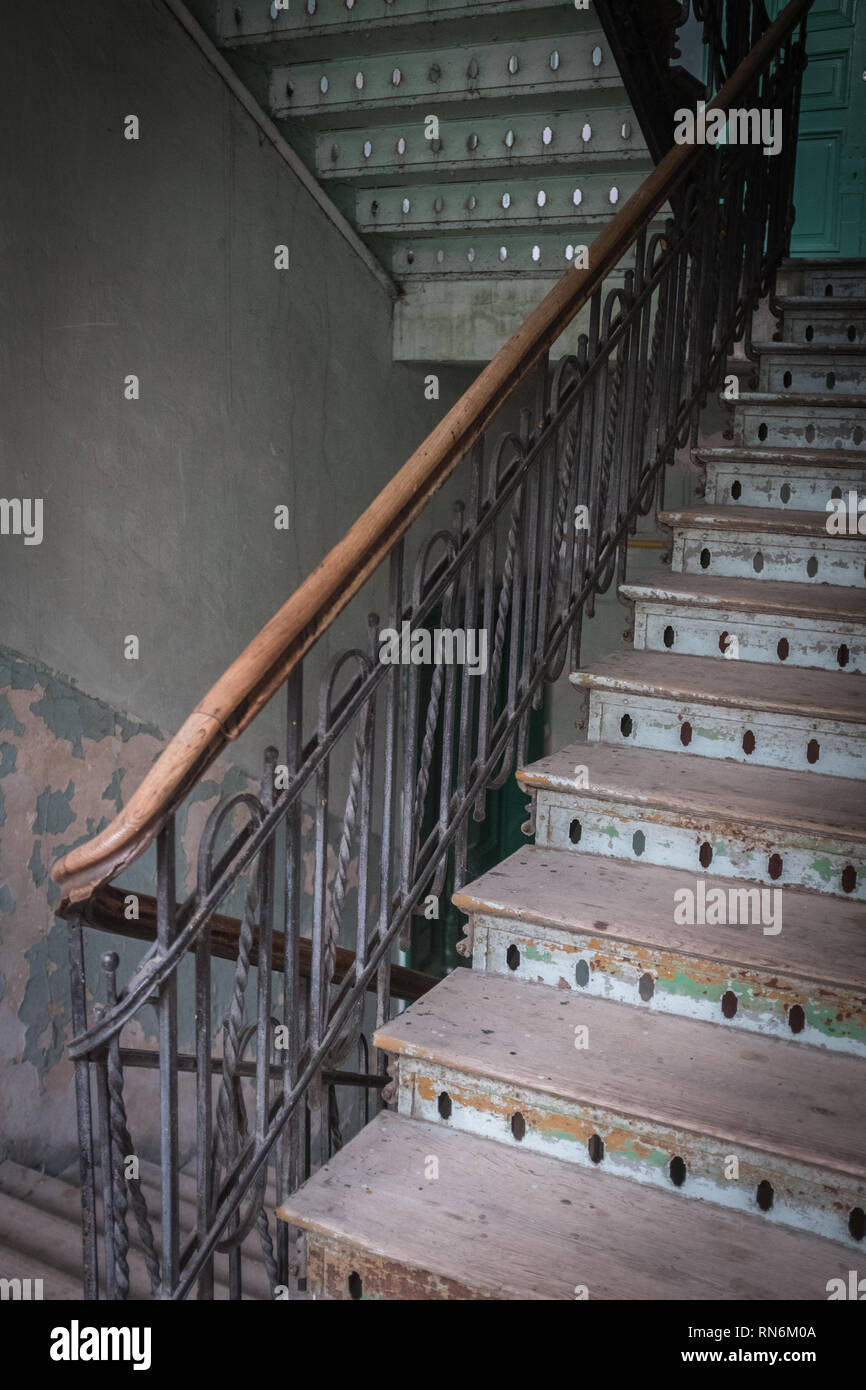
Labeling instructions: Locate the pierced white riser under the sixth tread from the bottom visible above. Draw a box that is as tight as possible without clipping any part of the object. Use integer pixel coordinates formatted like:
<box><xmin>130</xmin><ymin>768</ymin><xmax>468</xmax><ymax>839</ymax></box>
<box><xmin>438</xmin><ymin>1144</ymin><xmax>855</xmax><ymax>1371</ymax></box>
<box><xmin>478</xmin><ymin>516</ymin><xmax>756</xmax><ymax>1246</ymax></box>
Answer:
<box><xmin>634</xmin><ymin>603</ymin><xmax>866</xmax><ymax>674</ymax></box>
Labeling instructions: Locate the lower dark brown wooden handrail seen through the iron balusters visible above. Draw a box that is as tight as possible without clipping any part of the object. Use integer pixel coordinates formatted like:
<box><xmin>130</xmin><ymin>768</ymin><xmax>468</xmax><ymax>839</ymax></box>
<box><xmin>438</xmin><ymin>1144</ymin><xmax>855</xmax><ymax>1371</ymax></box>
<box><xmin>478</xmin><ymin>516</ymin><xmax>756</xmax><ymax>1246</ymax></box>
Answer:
<box><xmin>83</xmin><ymin>884</ymin><xmax>439</xmax><ymax>1002</ymax></box>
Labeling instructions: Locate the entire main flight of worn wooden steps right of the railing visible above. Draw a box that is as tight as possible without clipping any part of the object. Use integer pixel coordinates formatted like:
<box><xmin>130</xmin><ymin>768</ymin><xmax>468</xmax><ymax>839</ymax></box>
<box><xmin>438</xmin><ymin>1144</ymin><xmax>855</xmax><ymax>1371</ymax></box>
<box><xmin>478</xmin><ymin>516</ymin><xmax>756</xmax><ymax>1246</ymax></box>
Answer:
<box><xmin>279</xmin><ymin>261</ymin><xmax>866</xmax><ymax>1300</ymax></box>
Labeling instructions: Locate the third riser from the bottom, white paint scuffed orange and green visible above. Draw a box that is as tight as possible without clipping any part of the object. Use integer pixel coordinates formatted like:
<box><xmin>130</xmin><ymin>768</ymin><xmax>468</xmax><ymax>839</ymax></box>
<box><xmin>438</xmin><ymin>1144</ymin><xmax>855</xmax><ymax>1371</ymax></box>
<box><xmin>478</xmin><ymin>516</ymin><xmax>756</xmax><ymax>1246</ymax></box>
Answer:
<box><xmin>473</xmin><ymin>911</ymin><xmax>866</xmax><ymax>1056</ymax></box>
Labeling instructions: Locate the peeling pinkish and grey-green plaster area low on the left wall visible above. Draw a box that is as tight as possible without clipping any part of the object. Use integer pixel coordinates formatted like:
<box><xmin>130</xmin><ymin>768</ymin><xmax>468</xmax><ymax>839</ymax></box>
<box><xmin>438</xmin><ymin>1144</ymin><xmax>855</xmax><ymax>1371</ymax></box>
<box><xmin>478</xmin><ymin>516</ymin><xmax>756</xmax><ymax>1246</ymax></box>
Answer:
<box><xmin>0</xmin><ymin>648</ymin><xmax>369</xmax><ymax>1172</ymax></box>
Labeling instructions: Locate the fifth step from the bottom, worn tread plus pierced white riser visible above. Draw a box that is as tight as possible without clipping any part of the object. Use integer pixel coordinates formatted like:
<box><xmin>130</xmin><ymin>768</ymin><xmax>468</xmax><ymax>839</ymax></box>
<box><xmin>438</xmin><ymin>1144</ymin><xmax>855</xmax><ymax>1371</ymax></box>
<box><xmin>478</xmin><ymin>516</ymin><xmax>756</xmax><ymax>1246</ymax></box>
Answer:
<box><xmin>571</xmin><ymin>651</ymin><xmax>866</xmax><ymax>780</ymax></box>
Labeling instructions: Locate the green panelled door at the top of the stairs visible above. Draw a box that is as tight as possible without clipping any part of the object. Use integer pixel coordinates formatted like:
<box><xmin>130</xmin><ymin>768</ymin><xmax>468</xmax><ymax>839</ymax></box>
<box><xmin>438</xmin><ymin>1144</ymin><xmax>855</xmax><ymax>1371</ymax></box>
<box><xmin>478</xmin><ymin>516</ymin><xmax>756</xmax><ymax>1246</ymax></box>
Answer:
<box><xmin>789</xmin><ymin>0</ymin><xmax>866</xmax><ymax>257</ymax></box>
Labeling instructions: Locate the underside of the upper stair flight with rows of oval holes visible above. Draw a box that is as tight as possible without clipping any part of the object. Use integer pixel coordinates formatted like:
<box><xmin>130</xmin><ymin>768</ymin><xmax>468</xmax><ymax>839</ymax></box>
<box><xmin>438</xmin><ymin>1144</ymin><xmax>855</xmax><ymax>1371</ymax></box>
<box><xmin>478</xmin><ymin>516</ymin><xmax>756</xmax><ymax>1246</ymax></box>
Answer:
<box><xmin>202</xmin><ymin>0</ymin><xmax>692</xmax><ymax>353</ymax></box>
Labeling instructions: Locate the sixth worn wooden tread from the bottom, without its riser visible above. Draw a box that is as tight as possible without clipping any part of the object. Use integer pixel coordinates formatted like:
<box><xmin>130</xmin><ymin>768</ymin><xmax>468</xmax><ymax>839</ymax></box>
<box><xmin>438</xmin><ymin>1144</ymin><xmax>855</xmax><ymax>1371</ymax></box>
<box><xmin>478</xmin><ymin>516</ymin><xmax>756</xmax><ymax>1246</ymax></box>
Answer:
<box><xmin>620</xmin><ymin>574</ymin><xmax>866</xmax><ymax>624</ymax></box>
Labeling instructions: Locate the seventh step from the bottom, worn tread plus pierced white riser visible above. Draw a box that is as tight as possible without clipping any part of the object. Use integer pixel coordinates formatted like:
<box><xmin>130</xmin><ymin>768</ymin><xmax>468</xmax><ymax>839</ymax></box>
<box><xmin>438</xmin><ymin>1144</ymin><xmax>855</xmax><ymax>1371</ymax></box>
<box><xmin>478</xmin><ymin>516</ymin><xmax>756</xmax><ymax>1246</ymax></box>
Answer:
<box><xmin>659</xmin><ymin>500</ymin><xmax>866</xmax><ymax>588</ymax></box>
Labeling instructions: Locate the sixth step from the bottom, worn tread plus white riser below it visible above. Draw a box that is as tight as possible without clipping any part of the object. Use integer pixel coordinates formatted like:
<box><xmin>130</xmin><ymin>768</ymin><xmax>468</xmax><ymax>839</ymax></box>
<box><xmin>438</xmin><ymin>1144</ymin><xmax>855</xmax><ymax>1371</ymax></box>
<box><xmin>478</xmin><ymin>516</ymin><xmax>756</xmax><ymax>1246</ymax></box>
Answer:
<box><xmin>620</xmin><ymin>574</ymin><xmax>866</xmax><ymax>673</ymax></box>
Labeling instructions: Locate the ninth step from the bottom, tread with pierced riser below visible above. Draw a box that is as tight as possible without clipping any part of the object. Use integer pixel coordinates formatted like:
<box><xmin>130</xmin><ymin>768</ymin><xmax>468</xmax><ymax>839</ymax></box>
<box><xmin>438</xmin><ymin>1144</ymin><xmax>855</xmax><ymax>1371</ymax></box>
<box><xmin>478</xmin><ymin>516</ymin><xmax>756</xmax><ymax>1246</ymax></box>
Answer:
<box><xmin>734</xmin><ymin>391</ymin><xmax>866</xmax><ymax>456</ymax></box>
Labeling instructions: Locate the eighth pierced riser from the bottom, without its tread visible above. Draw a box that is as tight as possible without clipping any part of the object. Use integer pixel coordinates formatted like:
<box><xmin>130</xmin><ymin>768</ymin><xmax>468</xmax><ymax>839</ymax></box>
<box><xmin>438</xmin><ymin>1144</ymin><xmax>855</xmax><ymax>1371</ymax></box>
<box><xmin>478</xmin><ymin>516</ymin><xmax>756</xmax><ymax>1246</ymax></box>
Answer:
<box><xmin>705</xmin><ymin>463</ymin><xmax>866</xmax><ymax>512</ymax></box>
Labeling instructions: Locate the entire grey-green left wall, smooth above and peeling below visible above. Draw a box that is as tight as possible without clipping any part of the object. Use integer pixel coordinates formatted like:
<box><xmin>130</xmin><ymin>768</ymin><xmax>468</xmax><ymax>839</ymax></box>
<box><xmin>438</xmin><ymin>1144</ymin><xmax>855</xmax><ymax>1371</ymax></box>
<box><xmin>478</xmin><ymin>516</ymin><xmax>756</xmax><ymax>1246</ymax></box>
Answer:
<box><xmin>0</xmin><ymin>0</ymin><xmax>467</xmax><ymax>1172</ymax></box>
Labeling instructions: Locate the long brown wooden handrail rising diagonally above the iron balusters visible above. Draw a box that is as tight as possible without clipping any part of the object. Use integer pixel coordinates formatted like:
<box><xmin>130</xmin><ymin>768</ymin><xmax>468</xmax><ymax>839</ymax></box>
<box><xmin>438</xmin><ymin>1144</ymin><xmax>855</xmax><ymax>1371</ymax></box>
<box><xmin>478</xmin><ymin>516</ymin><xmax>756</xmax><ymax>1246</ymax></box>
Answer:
<box><xmin>51</xmin><ymin>0</ymin><xmax>812</xmax><ymax>912</ymax></box>
